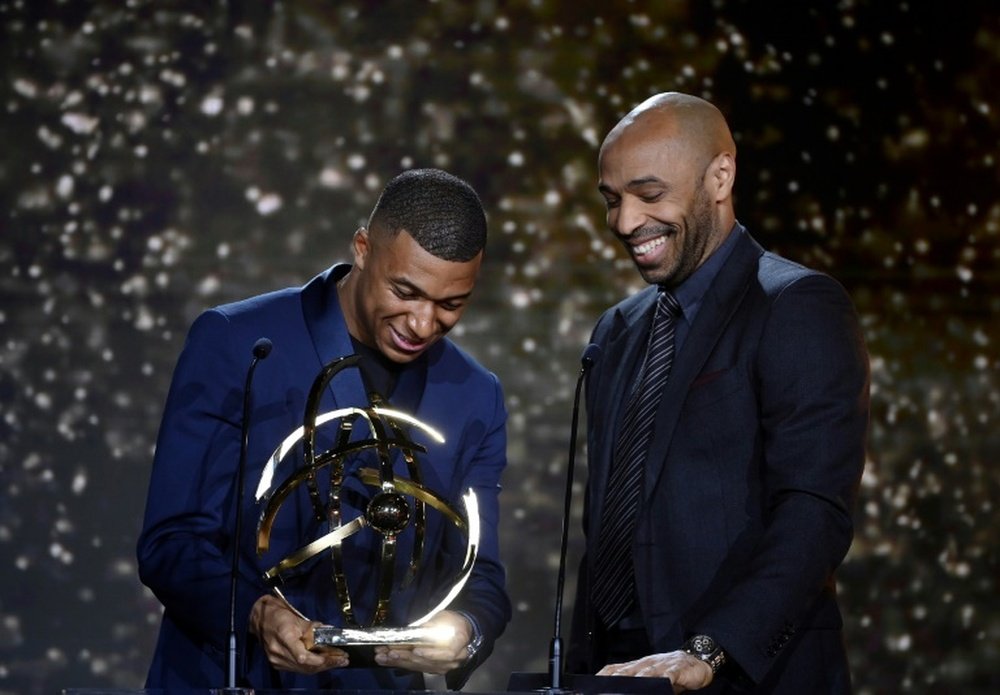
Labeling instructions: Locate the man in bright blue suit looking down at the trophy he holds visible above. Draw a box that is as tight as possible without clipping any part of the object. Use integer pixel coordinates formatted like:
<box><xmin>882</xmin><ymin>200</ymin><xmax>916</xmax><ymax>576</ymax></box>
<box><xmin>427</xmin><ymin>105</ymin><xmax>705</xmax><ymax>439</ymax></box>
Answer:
<box><xmin>138</xmin><ymin>169</ymin><xmax>511</xmax><ymax>690</ymax></box>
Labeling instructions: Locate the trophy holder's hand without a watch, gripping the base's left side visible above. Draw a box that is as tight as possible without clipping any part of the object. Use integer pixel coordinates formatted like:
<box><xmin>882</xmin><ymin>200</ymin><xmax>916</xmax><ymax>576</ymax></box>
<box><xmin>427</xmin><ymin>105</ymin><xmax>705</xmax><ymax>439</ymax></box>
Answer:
<box><xmin>250</xmin><ymin>595</ymin><xmax>347</xmax><ymax>673</ymax></box>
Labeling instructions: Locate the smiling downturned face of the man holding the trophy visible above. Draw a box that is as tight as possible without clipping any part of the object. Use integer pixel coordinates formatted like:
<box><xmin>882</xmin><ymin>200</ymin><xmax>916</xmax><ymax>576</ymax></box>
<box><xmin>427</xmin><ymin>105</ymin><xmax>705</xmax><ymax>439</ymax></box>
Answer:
<box><xmin>340</xmin><ymin>229</ymin><xmax>482</xmax><ymax>363</ymax></box>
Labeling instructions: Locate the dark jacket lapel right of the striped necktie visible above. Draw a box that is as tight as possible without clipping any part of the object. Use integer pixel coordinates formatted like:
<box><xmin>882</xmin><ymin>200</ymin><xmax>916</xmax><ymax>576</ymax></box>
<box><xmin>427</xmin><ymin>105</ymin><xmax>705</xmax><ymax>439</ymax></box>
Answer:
<box><xmin>643</xmin><ymin>230</ymin><xmax>764</xmax><ymax>502</ymax></box>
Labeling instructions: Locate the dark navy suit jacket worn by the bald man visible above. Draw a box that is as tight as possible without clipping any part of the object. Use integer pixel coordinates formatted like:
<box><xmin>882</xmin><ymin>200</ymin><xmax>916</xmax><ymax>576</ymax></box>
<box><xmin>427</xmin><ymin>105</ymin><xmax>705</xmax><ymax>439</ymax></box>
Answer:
<box><xmin>570</xmin><ymin>226</ymin><xmax>868</xmax><ymax>693</ymax></box>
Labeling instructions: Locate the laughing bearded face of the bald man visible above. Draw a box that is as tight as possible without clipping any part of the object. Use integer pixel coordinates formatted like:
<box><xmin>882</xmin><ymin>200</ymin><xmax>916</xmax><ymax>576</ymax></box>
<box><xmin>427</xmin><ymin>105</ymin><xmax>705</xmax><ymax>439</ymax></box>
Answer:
<box><xmin>598</xmin><ymin>93</ymin><xmax>735</xmax><ymax>287</ymax></box>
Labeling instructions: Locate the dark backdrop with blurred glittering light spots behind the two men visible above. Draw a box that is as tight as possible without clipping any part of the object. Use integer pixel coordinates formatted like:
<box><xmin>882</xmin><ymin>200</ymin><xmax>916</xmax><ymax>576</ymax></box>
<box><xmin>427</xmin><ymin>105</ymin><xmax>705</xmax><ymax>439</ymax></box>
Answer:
<box><xmin>0</xmin><ymin>0</ymin><xmax>1000</xmax><ymax>694</ymax></box>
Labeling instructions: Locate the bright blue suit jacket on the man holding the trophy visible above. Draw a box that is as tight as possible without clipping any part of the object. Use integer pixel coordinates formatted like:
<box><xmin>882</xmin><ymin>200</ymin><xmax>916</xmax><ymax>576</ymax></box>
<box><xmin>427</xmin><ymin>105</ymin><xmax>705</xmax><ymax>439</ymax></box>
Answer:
<box><xmin>138</xmin><ymin>265</ymin><xmax>510</xmax><ymax>689</ymax></box>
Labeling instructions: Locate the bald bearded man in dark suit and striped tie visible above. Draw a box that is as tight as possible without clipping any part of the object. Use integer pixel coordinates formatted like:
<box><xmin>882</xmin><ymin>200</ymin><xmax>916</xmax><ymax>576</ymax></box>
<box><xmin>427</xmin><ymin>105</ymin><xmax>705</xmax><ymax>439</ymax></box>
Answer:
<box><xmin>568</xmin><ymin>93</ymin><xmax>868</xmax><ymax>695</ymax></box>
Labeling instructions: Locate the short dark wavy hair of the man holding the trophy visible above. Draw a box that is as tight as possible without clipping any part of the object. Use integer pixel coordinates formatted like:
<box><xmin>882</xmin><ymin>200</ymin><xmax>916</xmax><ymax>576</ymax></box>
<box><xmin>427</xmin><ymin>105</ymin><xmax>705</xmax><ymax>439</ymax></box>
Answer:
<box><xmin>368</xmin><ymin>169</ymin><xmax>486</xmax><ymax>263</ymax></box>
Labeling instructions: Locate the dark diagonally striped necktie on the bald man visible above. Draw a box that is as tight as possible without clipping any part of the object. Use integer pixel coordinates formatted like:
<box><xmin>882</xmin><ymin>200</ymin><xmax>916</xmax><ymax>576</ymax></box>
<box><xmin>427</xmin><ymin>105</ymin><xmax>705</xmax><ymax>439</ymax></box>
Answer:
<box><xmin>591</xmin><ymin>290</ymin><xmax>680</xmax><ymax>627</ymax></box>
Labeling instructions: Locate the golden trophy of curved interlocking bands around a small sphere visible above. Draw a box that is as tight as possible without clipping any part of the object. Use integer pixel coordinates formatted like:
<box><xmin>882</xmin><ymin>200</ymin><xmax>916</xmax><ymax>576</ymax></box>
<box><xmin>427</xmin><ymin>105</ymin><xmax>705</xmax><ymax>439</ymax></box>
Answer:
<box><xmin>256</xmin><ymin>355</ymin><xmax>479</xmax><ymax>649</ymax></box>
